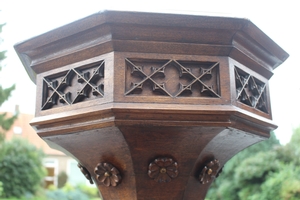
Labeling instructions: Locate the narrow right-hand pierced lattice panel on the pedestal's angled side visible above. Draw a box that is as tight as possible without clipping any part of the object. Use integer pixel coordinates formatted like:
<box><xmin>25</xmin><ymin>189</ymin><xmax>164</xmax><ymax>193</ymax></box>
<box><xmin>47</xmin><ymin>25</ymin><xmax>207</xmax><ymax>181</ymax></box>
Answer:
<box><xmin>234</xmin><ymin>67</ymin><xmax>268</xmax><ymax>113</ymax></box>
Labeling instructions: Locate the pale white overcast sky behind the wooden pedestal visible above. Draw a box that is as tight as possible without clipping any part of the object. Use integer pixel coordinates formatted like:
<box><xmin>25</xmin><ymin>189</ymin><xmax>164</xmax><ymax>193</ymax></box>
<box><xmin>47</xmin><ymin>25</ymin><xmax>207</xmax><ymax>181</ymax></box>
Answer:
<box><xmin>0</xmin><ymin>0</ymin><xmax>300</xmax><ymax>144</ymax></box>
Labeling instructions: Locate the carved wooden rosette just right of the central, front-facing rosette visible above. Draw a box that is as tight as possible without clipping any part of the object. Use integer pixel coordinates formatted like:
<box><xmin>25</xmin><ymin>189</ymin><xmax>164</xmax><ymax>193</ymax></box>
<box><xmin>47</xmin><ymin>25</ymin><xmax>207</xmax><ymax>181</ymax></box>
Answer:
<box><xmin>199</xmin><ymin>159</ymin><xmax>220</xmax><ymax>184</ymax></box>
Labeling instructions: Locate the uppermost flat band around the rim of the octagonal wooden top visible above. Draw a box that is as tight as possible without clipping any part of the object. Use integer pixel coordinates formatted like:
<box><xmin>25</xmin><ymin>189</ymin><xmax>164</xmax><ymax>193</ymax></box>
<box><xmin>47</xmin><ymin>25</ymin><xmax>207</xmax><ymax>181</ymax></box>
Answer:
<box><xmin>15</xmin><ymin>10</ymin><xmax>287</xmax><ymax>60</ymax></box>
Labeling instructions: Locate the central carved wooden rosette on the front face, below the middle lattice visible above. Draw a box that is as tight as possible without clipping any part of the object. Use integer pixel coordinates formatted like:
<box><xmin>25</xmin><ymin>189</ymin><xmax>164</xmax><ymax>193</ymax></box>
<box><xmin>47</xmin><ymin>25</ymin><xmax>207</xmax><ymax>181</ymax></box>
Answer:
<box><xmin>148</xmin><ymin>158</ymin><xmax>178</xmax><ymax>183</ymax></box>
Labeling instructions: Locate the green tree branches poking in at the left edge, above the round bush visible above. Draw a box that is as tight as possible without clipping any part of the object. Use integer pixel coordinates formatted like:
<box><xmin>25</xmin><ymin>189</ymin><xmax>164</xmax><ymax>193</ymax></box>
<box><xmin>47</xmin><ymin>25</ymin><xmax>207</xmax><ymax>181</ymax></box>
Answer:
<box><xmin>0</xmin><ymin>17</ymin><xmax>17</xmax><ymax>144</ymax></box>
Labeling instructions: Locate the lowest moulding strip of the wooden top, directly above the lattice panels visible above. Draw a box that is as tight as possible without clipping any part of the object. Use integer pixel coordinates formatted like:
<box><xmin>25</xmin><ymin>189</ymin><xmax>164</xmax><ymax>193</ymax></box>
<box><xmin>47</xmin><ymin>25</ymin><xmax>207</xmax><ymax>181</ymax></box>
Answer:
<box><xmin>17</xmin><ymin>40</ymin><xmax>279</xmax><ymax>83</ymax></box>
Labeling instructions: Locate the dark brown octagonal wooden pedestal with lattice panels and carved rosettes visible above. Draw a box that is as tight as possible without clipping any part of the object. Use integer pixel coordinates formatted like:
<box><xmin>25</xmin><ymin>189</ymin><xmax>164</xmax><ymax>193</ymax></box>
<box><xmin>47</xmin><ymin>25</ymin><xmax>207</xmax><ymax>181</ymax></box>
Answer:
<box><xmin>15</xmin><ymin>11</ymin><xmax>288</xmax><ymax>200</ymax></box>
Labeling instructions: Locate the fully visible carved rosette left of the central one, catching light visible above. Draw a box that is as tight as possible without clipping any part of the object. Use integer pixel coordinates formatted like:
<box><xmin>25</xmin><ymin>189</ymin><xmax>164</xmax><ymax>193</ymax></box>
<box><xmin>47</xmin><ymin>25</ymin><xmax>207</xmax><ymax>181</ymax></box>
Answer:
<box><xmin>94</xmin><ymin>163</ymin><xmax>122</xmax><ymax>187</ymax></box>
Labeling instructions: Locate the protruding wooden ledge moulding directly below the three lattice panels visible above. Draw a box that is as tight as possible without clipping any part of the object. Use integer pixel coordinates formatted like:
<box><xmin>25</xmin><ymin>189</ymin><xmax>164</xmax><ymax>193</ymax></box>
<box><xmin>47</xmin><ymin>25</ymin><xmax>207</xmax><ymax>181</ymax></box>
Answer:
<box><xmin>30</xmin><ymin>103</ymin><xmax>277</xmax><ymax>137</ymax></box>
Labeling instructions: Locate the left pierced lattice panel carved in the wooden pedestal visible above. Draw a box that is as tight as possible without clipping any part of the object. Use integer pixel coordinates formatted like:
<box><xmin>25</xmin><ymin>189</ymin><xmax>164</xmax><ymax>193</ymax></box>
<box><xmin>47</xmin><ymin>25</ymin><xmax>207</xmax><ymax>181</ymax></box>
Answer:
<box><xmin>42</xmin><ymin>61</ymin><xmax>104</xmax><ymax>110</ymax></box>
